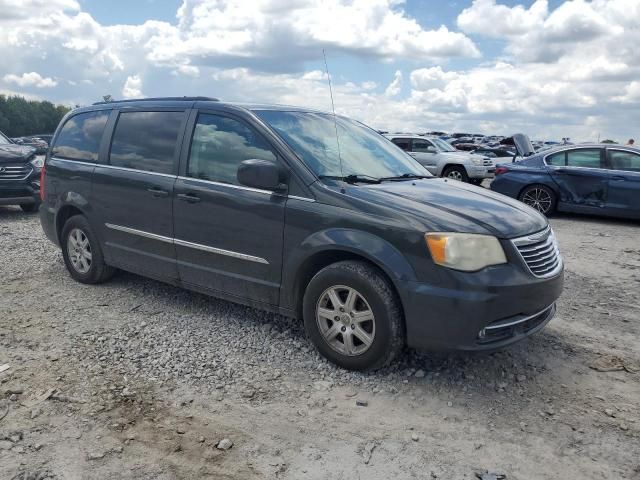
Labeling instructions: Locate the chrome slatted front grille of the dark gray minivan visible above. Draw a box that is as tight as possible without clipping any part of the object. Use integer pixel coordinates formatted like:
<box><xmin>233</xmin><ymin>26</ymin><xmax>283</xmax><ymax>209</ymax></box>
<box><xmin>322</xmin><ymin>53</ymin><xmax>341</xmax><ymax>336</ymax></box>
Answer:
<box><xmin>512</xmin><ymin>227</ymin><xmax>562</xmax><ymax>278</ymax></box>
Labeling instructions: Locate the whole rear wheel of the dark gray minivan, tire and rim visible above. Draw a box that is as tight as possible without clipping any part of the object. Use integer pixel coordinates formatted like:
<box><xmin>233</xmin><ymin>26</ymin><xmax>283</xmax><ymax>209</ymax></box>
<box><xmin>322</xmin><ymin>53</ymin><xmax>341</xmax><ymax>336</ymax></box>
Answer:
<box><xmin>60</xmin><ymin>215</ymin><xmax>115</xmax><ymax>284</ymax></box>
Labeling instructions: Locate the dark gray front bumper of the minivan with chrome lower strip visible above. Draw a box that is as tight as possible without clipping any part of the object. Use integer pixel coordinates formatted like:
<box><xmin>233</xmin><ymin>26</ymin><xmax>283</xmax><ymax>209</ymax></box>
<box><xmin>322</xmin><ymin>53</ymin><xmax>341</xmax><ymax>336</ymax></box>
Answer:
<box><xmin>401</xmin><ymin>265</ymin><xmax>564</xmax><ymax>351</ymax></box>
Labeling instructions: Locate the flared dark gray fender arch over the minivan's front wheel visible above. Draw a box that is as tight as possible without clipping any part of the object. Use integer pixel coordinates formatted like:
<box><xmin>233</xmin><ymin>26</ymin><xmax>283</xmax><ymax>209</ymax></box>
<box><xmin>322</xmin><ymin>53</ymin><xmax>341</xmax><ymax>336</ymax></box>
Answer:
<box><xmin>280</xmin><ymin>228</ymin><xmax>416</xmax><ymax>310</ymax></box>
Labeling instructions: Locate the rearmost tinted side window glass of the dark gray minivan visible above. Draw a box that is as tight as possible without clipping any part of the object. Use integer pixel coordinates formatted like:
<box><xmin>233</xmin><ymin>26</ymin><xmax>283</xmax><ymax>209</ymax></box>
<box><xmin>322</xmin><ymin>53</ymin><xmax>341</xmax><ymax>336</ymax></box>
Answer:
<box><xmin>51</xmin><ymin>110</ymin><xmax>111</xmax><ymax>162</ymax></box>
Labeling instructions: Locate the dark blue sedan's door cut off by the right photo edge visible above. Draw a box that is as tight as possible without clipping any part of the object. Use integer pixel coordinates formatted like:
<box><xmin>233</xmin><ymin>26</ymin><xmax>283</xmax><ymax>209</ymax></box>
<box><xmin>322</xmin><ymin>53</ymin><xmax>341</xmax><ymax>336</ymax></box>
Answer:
<box><xmin>607</xmin><ymin>148</ymin><xmax>640</xmax><ymax>218</ymax></box>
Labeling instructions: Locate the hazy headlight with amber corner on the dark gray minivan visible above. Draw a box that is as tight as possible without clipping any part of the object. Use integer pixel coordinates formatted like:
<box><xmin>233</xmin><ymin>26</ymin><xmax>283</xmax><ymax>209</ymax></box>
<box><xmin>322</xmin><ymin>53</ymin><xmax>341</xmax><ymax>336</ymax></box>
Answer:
<box><xmin>424</xmin><ymin>233</ymin><xmax>507</xmax><ymax>272</ymax></box>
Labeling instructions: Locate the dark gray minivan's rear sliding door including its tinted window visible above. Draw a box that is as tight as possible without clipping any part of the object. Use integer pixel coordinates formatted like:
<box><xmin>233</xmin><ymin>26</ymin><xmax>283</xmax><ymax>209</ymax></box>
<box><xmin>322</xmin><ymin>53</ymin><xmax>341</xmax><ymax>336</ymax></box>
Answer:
<box><xmin>92</xmin><ymin>110</ymin><xmax>187</xmax><ymax>281</ymax></box>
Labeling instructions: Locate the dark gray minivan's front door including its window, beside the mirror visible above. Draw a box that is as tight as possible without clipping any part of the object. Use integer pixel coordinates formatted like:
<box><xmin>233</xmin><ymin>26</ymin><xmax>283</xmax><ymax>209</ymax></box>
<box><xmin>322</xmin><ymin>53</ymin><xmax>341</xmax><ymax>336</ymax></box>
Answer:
<box><xmin>173</xmin><ymin>112</ymin><xmax>286</xmax><ymax>305</ymax></box>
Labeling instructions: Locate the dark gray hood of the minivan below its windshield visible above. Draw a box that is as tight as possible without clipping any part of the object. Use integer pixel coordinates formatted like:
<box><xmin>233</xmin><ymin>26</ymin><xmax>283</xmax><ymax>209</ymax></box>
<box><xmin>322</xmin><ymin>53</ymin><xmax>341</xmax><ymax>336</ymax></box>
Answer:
<box><xmin>346</xmin><ymin>178</ymin><xmax>548</xmax><ymax>238</ymax></box>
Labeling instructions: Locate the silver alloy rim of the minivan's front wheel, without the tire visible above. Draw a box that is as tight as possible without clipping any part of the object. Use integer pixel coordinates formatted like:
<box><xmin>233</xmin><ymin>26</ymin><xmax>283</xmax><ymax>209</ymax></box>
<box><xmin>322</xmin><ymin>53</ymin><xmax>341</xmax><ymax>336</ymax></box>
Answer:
<box><xmin>316</xmin><ymin>285</ymin><xmax>376</xmax><ymax>357</ymax></box>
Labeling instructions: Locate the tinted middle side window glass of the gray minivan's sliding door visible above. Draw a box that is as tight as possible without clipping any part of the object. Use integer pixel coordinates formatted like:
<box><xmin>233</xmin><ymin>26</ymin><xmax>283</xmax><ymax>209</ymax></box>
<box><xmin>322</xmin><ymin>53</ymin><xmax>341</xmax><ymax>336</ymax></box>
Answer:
<box><xmin>109</xmin><ymin>112</ymin><xmax>184</xmax><ymax>173</ymax></box>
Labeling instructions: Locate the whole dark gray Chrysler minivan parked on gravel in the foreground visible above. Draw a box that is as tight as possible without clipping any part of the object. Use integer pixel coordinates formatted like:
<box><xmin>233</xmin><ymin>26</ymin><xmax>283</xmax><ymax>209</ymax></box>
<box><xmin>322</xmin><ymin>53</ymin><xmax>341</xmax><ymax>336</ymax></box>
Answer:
<box><xmin>40</xmin><ymin>97</ymin><xmax>563</xmax><ymax>370</ymax></box>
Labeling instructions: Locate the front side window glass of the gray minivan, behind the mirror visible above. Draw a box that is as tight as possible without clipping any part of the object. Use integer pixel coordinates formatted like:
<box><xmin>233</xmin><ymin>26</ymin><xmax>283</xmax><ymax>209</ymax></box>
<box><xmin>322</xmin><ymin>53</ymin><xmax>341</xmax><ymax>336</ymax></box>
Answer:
<box><xmin>187</xmin><ymin>114</ymin><xmax>276</xmax><ymax>185</ymax></box>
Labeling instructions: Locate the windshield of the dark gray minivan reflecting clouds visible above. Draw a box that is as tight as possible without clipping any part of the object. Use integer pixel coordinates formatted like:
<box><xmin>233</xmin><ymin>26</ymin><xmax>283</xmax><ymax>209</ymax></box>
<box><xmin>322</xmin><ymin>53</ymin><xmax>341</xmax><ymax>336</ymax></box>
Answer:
<box><xmin>255</xmin><ymin>110</ymin><xmax>431</xmax><ymax>181</ymax></box>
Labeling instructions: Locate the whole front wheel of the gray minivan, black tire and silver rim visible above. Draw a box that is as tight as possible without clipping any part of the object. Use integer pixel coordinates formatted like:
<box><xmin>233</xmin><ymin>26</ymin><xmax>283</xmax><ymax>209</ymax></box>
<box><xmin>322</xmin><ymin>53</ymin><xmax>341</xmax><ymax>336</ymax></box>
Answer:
<box><xmin>303</xmin><ymin>261</ymin><xmax>405</xmax><ymax>371</ymax></box>
